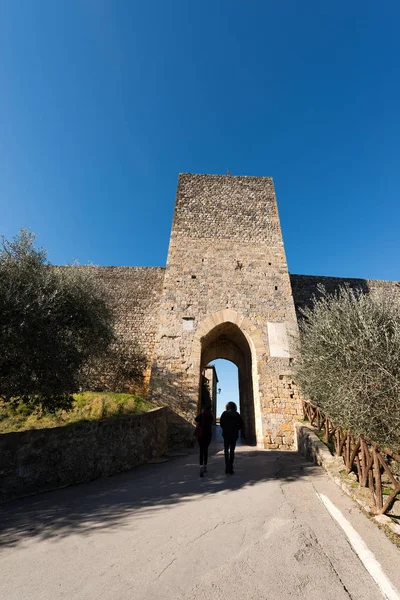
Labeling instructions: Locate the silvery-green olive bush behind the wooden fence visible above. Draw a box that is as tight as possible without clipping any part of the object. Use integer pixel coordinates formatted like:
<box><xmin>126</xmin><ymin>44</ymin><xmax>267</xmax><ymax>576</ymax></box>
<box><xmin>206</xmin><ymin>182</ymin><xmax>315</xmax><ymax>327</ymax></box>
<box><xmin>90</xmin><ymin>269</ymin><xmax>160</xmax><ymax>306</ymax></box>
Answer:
<box><xmin>294</xmin><ymin>287</ymin><xmax>400</xmax><ymax>449</ymax></box>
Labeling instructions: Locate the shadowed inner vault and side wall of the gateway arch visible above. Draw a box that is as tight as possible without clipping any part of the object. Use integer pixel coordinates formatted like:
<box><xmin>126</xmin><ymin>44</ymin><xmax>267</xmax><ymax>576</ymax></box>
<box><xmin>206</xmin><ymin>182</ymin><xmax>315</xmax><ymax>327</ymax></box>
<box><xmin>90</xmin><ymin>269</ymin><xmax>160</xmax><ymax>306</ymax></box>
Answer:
<box><xmin>199</xmin><ymin>321</ymin><xmax>256</xmax><ymax>445</ymax></box>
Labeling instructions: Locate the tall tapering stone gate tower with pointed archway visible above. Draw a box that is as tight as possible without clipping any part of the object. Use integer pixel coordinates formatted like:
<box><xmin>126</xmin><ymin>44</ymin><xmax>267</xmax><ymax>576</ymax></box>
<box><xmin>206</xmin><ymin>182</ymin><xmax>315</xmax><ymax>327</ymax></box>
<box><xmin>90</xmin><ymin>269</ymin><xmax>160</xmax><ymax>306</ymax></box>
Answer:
<box><xmin>150</xmin><ymin>174</ymin><xmax>301</xmax><ymax>449</ymax></box>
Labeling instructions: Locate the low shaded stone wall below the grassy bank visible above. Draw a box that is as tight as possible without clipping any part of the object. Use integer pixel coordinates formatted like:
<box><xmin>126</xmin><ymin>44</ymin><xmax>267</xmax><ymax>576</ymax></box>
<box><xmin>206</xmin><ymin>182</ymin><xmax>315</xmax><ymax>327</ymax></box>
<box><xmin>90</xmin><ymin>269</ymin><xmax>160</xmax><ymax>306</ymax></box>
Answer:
<box><xmin>0</xmin><ymin>408</ymin><xmax>167</xmax><ymax>502</ymax></box>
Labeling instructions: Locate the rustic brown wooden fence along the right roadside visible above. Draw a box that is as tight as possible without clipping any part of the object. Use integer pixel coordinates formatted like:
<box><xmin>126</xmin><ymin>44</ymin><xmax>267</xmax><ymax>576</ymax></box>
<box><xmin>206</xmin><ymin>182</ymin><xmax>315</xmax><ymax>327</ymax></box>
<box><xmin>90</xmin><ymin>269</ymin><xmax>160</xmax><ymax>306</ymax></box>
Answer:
<box><xmin>303</xmin><ymin>400</ymin><xmax>400</xmax><ymax>515</ymax></box>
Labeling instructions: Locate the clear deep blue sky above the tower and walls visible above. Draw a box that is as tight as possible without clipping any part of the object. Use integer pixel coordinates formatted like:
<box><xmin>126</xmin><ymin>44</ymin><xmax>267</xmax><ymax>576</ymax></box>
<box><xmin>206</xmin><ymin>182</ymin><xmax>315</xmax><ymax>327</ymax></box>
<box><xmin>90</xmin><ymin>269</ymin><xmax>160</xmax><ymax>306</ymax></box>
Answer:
<box><xmin>0</xmin><ymin>0</ymin><xmax>400</xmax><ymax>280</ymax></box>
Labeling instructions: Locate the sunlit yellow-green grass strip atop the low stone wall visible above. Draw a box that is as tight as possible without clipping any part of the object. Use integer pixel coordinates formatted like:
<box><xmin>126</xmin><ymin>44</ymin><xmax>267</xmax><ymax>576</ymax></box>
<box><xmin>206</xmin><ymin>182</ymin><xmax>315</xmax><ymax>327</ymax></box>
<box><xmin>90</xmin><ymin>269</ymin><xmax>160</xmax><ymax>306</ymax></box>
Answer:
<box><xmin>0</xmin><ymin>392</ymin><xmax>155</xmax><ymax>433</ymax></box>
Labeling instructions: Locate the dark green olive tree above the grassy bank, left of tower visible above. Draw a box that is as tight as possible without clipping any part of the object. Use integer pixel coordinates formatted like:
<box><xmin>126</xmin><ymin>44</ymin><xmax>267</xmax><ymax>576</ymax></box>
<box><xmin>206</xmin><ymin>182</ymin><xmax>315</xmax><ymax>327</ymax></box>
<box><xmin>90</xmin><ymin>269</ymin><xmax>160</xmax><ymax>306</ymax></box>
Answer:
<box><xmin>0</xmin><ymin>230</ymin><xmax>113</xmax><ymax>410</ymax></box>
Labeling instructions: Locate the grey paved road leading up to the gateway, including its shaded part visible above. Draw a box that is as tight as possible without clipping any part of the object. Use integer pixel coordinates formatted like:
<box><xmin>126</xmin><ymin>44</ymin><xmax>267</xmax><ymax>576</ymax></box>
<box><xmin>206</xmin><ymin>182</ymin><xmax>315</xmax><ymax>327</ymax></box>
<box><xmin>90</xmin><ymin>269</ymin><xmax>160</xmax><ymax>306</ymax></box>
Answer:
<box><xmin>0</xmin><ymin>436</ymin><xmax>400</xmax><ymax>600</ymax></box>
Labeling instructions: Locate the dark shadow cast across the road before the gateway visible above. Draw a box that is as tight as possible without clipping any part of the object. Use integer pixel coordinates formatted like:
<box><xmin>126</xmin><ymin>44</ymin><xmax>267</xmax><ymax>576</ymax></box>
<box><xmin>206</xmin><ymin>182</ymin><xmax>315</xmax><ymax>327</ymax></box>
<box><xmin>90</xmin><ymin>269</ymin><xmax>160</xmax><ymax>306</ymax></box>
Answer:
<box><xmin>0</xmin><ymin>441</ymin><xmax>320</xmax><ymax>547</ymax></box>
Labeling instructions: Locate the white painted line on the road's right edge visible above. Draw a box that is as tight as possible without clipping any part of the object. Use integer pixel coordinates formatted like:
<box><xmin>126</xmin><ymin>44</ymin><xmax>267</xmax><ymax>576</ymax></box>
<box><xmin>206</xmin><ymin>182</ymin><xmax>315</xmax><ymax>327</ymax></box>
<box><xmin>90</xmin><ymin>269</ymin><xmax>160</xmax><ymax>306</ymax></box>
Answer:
<box><xmin>316</xmin><ymin>492</ymin><xmax>400</xmax><ymax>600</ymax></box>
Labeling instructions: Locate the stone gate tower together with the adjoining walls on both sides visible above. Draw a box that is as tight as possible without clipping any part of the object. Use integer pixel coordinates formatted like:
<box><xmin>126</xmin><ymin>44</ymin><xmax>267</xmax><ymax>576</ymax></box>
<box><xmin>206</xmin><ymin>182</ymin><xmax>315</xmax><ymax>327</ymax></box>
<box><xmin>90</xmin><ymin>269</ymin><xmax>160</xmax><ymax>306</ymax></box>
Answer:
<box><xmin>49</xmin><ymin>174</ymin><xmax>400</xmax><ymax>448</ymax></box>
